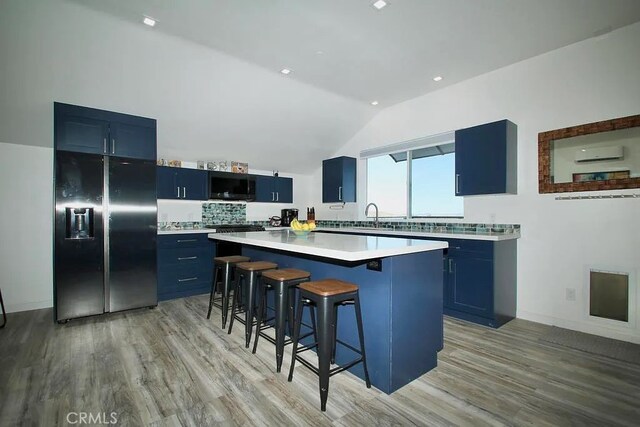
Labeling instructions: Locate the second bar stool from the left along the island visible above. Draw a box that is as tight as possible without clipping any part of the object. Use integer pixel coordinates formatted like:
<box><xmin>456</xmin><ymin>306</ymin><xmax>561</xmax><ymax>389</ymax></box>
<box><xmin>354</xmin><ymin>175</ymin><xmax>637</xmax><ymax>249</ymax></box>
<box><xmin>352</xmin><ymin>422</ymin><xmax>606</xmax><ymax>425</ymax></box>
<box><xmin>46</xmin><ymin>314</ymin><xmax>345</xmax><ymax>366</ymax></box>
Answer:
<box><xmin>228</xmin><ymin>261</ymin><xmax>278</xmax><ymax>348</ymax></box>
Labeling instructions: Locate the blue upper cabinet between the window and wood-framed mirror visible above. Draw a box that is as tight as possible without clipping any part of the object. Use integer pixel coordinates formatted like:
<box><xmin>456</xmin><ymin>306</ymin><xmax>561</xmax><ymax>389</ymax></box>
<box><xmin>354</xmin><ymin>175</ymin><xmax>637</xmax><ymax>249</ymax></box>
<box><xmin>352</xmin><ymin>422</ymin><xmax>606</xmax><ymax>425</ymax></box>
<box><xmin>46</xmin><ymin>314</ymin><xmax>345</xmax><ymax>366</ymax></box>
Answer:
<box><xmin>455</xmin><ymin>120</ymin><xmax>518</xmax><ymax>196</ymax></box>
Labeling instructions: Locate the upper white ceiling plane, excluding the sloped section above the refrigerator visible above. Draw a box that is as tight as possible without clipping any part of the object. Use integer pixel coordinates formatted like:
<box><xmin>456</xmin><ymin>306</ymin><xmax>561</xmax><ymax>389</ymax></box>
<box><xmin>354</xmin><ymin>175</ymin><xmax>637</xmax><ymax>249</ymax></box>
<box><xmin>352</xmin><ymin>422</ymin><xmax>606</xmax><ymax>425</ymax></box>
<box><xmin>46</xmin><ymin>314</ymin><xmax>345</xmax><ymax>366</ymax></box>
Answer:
<box><xmin>67</xmin><ymin>0</ymin><xmax>640</xmax><ymax>108</ymax></box>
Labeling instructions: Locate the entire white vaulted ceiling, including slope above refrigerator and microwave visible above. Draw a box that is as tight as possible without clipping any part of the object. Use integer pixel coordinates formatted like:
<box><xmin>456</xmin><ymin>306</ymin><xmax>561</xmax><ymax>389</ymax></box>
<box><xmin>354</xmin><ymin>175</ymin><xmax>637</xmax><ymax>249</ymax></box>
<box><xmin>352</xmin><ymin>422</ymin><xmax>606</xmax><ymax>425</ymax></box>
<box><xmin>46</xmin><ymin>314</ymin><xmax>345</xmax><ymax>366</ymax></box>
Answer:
<box><xmin>0</xmin><ymin>0</ymin><xmax>640</xmax><ymax>173</ymax></box>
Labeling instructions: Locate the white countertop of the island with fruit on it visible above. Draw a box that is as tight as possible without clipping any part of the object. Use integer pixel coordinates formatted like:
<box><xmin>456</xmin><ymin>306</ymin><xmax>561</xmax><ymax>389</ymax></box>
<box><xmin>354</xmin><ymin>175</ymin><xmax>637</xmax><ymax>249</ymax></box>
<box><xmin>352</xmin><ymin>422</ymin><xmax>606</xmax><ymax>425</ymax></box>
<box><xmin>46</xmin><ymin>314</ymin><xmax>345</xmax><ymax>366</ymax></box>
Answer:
<box><xmin>208</xmin><ymin>229</ymin><xmax>448</xmax><ymax>261</ymax></box>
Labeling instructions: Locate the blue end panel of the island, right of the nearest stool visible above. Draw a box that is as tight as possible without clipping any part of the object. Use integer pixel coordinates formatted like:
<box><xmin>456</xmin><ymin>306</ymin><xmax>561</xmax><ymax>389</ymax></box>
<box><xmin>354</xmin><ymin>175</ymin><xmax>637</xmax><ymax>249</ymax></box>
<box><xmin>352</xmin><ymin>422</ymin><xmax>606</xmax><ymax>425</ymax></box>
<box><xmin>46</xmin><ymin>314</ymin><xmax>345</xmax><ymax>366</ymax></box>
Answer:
<box><xmin>389</xmin><ymin>250</ymin><xmax>443</xmax><ymax>392</ymax></box>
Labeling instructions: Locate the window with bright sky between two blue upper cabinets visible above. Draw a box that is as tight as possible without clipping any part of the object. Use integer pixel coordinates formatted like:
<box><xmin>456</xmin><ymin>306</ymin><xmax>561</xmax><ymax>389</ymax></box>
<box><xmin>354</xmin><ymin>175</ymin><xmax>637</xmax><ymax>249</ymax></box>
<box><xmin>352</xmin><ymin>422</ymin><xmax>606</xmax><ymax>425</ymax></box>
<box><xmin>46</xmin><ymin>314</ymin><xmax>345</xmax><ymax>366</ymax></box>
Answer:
<box><xmin>361</xmin><ymin>140</ymin><xmax>464</xmax><ymax>218</ymax></box>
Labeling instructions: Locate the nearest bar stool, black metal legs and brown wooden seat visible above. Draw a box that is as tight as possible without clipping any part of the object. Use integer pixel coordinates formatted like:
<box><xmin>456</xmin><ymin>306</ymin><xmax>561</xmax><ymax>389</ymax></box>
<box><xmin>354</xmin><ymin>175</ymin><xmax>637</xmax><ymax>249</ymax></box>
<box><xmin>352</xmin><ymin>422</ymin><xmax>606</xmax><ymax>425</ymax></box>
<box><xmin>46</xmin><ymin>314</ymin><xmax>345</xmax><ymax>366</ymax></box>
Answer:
<box><xmin>288</xmin><ymin>279</ymin><xmax>371</xmax><ymax>411</ymax></box>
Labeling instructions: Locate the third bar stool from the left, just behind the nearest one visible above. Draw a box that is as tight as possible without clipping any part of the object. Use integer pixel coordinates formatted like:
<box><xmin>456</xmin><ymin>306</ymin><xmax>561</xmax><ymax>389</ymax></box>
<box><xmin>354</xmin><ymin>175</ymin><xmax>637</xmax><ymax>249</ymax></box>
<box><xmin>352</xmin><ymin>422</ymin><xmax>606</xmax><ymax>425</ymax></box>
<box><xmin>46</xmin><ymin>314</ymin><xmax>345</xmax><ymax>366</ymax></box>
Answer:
<box><xmin>253</xmin><ymin>268</ymin><xmax>316</xmax><ymax>372</ymax></box>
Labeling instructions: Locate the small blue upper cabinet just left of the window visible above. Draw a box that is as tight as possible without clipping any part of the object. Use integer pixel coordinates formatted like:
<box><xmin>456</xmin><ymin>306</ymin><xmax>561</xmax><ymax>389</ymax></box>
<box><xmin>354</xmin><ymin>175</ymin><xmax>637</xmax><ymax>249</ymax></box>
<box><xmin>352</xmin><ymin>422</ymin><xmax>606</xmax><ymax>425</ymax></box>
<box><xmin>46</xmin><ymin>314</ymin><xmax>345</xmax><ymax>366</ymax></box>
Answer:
<box><xmin>322</xmin><ymin>156</ymin><xmax>356</xmax><ymax>203</ymax></box>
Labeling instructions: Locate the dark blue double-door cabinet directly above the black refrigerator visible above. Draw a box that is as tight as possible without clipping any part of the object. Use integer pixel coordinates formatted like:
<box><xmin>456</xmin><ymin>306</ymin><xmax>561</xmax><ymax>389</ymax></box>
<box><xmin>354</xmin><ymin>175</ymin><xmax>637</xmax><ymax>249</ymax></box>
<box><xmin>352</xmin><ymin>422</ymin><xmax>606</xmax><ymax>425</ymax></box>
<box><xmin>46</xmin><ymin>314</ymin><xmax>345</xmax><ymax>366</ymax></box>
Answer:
<box><xmin>54</xmin><ymin>102</ymin><xmax>156</xmax><ymax>160</ymax></box>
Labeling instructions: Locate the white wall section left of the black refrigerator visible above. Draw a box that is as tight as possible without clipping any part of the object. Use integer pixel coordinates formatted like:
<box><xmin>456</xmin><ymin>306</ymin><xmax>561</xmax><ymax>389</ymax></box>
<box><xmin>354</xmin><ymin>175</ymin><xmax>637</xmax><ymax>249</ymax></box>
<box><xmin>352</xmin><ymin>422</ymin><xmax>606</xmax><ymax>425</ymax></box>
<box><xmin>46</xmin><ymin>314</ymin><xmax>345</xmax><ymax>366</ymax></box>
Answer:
<box><xmin>0</xmin><ymin>143</ymin><xmax>53</xmax><ymax>312</ymax></box>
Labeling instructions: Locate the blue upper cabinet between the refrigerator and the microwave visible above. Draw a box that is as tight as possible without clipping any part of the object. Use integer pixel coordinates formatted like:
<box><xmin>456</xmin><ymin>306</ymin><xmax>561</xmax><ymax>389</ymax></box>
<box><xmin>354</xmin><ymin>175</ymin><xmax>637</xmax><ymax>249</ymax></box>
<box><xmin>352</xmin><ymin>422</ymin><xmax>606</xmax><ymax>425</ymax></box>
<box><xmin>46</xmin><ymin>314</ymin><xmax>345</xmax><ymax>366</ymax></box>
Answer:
<box><xmin>156</xmin><ymin>166</ymin><xmax>209</xmax><ymax>200</ymax></box>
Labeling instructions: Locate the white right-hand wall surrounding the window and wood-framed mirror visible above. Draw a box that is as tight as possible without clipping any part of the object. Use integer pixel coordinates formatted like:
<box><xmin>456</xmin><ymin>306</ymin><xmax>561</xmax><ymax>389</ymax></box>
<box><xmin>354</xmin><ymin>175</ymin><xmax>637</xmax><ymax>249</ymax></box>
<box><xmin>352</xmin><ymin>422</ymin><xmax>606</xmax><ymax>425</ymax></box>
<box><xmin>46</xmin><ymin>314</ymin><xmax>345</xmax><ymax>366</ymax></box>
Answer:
<box><xmin>314</xmin><ymin>24</ymin><xmax>640</xmax><ymax>342</ymax></box>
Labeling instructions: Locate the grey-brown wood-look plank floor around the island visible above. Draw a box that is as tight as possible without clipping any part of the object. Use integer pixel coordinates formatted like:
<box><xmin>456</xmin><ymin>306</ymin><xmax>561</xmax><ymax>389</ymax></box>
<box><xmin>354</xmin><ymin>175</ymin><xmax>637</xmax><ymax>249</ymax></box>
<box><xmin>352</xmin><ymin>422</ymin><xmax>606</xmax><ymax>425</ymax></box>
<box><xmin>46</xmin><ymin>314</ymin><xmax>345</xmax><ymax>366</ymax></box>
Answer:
<box><xmin>0</xmin><ymin>296</ymin><xmax>640</xmax><ymax>426</ymax></box>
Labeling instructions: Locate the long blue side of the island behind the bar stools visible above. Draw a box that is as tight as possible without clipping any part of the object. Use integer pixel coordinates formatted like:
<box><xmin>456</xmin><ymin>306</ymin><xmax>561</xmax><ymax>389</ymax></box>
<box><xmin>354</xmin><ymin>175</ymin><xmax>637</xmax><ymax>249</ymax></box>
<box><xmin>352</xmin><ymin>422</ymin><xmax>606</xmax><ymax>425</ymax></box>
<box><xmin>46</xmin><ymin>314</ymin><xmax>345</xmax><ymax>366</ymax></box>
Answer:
<box><xmin>242</xmin><ymin>246</ymin><xmax>393</xmax><ymax>393</ymax></box>
